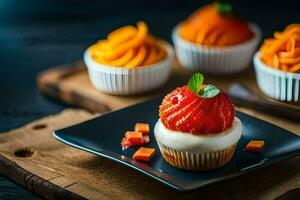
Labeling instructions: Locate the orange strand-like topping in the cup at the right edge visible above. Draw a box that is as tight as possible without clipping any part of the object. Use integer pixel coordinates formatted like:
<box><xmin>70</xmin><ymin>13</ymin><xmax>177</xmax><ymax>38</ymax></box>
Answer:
<box><xmin>260</xmin><ymin>24</ymin><xmax>300</xmax><ymax>73</ymax></box>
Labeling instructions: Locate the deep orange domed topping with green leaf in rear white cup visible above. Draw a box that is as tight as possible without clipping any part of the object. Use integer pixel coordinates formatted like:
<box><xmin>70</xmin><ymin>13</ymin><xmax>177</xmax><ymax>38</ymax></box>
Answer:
<box><xmin>178</xmin><ymin>2</ymin><xmax>253</xmax><ymax>47</ymax></box>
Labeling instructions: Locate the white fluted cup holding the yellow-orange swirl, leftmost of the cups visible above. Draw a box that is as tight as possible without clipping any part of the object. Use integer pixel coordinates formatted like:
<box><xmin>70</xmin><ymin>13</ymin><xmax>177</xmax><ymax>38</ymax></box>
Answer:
<box><xmin>84</xmin><ymin>42</ymin><xmax>174</xmax><ymax>95</ymax></box>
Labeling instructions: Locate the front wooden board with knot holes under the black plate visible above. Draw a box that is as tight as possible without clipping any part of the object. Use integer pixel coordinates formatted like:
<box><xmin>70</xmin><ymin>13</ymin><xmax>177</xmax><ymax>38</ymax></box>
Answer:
<box><xmin>0</xmin><ymin>109</ymin><xmax>300</xmax><ymax>200</ymax></box>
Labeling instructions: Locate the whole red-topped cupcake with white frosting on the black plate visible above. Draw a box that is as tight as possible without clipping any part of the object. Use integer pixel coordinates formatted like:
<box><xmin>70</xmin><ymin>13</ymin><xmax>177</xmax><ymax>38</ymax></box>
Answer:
<box><xmin>154</xmin><ymin>73</ymin><xmax>242</xmax><ymax>171</ymax></box>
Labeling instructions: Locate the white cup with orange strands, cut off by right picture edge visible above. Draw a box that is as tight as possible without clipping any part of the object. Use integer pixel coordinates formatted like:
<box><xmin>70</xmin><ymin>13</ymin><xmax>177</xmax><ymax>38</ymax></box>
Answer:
<box><xmin>253</xmin><ymin>24</ymin><xmax>300</xmax><ymax>102</ymax></box>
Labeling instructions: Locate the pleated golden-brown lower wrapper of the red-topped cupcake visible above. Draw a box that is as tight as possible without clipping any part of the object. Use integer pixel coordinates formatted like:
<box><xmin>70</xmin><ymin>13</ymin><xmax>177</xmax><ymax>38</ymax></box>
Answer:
<box><xmin>158</xmin><ymin>142</ymin><xmax>236</xmax><ymax>171</ymax></box>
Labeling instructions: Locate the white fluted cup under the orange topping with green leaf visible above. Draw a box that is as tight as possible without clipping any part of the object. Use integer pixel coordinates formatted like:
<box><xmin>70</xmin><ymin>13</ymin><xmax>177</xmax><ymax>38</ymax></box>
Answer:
<box><xmin>172</xmin><ymin>24</ymin><xmax>261</xmax><ymax>74</ymax></box>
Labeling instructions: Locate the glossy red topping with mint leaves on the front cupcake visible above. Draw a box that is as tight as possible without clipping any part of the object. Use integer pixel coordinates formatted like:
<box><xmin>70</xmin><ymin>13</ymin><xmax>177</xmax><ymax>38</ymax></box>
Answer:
<box><xmin>159</xmin><ymin>73</ymin><xmax>234</xmax><ymax>135</ymax></box>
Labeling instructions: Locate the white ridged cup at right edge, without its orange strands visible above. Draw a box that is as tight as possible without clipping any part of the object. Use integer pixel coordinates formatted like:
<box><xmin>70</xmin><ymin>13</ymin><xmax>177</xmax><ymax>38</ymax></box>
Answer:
<box><xmin>253</xmin><ymin>52</ymin><xmax>300</xmax><ymax>102</ymax></box>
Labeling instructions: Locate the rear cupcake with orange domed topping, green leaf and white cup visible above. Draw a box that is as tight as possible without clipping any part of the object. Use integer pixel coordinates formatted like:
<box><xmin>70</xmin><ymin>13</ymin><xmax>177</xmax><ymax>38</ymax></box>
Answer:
<box><xmin>172</xmin><ymin>2</ymin><xmax>261</xmax><ymax>74</ymax></box>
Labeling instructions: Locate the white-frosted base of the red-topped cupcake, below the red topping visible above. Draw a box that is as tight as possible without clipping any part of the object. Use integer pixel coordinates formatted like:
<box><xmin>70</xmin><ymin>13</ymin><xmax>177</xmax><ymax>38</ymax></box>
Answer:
<box><xmin>154</xmin><ymin>117</ymin><xmax>242</xmax><ymax>171</ymax></box>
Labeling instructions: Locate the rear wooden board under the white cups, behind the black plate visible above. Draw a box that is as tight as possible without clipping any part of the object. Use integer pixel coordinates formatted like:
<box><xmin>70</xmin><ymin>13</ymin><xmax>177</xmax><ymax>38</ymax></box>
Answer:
<box><xmin>37</xmin><ymin>61</ymin><xmax>300</xmax><ymax>113</ymax></box>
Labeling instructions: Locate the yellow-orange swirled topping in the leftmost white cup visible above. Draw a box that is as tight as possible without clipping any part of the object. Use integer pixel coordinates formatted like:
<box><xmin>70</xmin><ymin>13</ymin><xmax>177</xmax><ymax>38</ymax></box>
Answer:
<box><xmin>88</xmin><ymin>21</ymin><xmax>167</xmax><ymax>68</ymax></box>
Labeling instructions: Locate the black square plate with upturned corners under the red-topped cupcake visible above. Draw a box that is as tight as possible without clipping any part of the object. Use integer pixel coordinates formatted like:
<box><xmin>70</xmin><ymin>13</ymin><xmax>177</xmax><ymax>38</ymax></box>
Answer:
<box><xmin>53</xmin><ymin>98</ymin><xmax>300</xmax><ymax>191</ymax></box>
